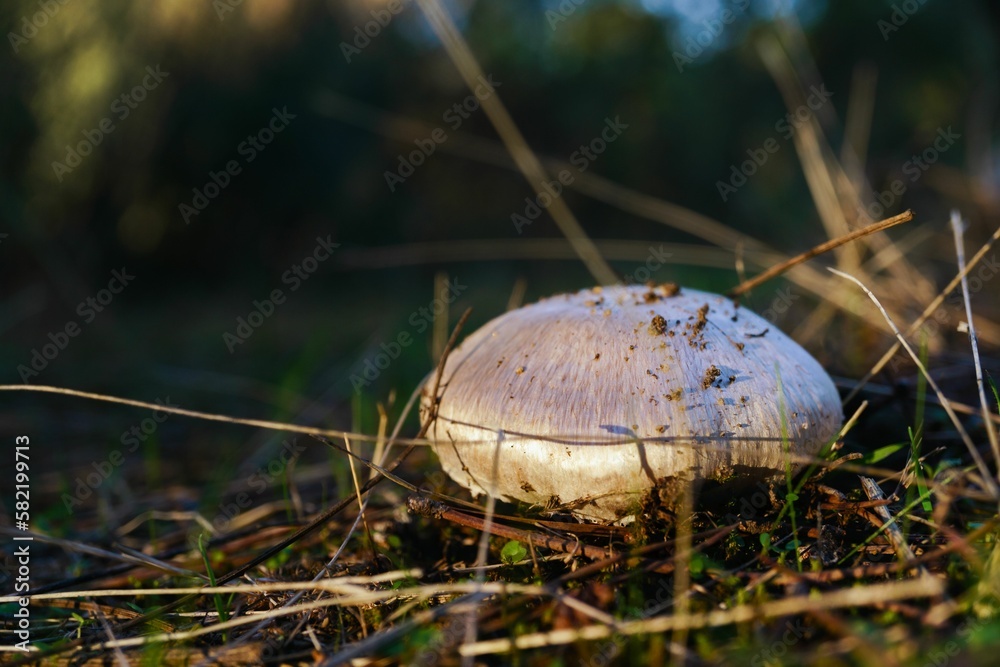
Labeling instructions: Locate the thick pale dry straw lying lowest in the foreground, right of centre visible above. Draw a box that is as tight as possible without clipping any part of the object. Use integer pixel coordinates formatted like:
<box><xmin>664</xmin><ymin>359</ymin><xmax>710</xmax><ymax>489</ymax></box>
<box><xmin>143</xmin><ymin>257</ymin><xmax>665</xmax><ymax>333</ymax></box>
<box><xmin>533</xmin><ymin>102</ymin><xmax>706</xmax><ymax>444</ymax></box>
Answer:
<box><xmin>460</xmin><ymin>577</ymin><xmax>944</xmax><ymax>655</ymax></box>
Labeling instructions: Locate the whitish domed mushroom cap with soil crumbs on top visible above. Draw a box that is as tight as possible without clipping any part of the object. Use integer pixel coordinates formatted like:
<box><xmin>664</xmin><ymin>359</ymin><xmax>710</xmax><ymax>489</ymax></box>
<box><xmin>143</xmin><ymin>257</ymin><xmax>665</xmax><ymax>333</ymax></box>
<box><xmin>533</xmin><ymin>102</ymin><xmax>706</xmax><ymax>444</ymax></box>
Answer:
<box><xmin>421</xmin><ymin>284</ymin><xmax>843</xmax><ymax>522</ymax></box>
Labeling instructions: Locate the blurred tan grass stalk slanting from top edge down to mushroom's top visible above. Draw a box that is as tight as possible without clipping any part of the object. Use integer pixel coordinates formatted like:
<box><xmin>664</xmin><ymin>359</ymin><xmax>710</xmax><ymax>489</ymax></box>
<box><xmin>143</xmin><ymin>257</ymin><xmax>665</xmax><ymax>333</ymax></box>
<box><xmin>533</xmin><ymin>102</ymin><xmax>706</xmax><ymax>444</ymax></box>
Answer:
<box><xmin>417</xmin><ymin>0</ymin><xmax>618</xmax><ymax>285</ymax></box>
